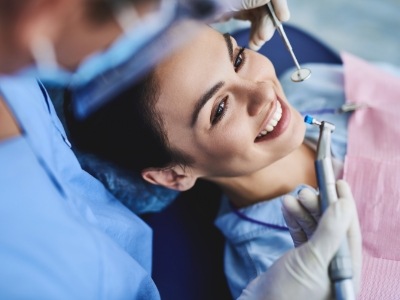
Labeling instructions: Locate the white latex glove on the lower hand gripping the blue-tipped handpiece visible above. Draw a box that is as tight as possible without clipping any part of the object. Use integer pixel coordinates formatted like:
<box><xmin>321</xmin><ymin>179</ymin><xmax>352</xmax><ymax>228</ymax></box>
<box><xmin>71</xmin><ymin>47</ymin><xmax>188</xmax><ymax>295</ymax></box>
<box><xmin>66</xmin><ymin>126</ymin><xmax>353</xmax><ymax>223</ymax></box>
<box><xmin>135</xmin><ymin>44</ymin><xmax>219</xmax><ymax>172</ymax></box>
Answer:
<box><xmin>239</xmin><ymin>181</ymin><xmax>361</xmax><ymax>300</ymax></box>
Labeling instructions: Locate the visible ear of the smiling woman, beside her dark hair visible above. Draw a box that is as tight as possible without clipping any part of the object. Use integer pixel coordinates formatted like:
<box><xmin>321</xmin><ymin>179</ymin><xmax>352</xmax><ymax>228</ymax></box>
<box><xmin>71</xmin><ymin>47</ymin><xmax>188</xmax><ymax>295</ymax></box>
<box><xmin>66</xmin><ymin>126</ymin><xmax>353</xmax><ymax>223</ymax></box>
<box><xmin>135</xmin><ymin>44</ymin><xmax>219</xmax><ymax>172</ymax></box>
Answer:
<box><xmin>142</xmin><ymin>166</ymin><xmax>197</xmax><ymax>192</ymax></box>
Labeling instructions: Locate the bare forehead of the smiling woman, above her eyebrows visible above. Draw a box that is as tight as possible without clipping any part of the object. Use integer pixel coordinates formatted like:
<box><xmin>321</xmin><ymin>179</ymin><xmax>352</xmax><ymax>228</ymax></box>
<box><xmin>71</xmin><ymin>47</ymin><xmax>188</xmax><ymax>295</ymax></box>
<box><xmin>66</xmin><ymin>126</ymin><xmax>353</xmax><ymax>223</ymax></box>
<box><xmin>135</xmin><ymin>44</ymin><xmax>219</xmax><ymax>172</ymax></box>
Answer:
<box><xmin>156</xmin><ymin>26</ymin><xmax>230</xmax><ymax>124</ymax></box>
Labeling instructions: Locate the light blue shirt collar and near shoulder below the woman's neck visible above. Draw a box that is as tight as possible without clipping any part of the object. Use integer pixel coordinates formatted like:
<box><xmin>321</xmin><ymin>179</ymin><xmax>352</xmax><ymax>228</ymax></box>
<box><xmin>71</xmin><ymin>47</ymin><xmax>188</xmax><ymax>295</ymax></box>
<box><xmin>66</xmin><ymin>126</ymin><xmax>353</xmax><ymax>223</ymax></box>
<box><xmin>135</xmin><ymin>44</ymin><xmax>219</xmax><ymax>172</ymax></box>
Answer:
<box><xmin>215</xmin><ymin>186</ymin><xmax>305</xmax><ymax>299</ymax></box>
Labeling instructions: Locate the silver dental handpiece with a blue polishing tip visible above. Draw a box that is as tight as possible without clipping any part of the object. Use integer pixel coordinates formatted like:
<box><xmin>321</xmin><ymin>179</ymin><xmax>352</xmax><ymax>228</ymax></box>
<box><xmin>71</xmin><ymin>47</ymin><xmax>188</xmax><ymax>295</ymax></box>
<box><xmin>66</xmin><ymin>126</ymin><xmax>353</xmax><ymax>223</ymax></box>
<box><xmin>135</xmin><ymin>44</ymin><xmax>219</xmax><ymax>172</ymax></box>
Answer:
<box><xmin>304</xmin><ymin>115</ymin><xmax>355</xmax><ymax>300</ymax></box>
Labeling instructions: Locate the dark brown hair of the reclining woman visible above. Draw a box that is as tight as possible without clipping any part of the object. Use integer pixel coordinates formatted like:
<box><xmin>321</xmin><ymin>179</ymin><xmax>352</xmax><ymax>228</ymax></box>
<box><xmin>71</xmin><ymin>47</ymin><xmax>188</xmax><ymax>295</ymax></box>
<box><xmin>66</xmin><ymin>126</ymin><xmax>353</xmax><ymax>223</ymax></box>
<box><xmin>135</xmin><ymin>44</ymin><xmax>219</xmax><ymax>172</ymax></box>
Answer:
<box><xmin>66</xmin><ymin>73</ymin><xmax>193</xmax><ymax>172</ymax></box>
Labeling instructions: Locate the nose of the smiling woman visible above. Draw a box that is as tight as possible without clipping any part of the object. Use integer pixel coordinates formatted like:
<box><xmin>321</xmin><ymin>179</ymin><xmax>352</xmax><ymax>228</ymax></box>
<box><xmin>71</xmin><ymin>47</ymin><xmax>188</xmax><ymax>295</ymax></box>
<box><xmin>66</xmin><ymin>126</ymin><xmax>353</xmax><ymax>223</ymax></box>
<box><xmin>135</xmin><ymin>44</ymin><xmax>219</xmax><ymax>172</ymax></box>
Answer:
<box><xmin>241</xmin><ymin>81</ymin><xmax>276</xmax><ymax>116</ymax></box>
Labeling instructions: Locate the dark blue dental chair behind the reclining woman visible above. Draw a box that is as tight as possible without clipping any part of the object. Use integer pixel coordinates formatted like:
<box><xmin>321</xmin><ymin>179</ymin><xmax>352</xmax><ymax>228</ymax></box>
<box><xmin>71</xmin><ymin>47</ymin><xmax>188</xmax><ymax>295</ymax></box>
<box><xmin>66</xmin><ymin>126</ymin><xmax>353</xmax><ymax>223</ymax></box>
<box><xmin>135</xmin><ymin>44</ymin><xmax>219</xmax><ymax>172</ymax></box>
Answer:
<box><xmin>142</xmin><ymin>24</ymin><xmax>342</xmax><ymax>300</ymax></box>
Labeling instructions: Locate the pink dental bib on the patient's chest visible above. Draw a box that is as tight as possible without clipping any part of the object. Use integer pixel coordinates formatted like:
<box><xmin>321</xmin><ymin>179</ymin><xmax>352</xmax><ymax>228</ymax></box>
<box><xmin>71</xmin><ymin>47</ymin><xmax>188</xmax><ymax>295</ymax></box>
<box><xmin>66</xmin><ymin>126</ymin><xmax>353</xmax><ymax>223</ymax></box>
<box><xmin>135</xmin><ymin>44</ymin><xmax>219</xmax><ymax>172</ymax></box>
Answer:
<box><xmin>342</xmin><ymin>53</ymin><xmax>400</xmax><ymax>300</ymax></box>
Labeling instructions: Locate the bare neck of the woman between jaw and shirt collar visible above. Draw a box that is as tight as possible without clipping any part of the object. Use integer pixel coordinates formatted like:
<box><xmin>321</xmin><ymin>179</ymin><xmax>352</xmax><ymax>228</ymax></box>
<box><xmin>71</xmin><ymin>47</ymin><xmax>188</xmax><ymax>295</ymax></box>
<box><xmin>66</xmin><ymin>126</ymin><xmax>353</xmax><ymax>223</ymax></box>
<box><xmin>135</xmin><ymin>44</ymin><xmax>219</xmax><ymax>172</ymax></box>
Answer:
<box><xmin>209</xmin><ymin>144</ymin><xmax>317</xmax><ymax>207</ymax></box>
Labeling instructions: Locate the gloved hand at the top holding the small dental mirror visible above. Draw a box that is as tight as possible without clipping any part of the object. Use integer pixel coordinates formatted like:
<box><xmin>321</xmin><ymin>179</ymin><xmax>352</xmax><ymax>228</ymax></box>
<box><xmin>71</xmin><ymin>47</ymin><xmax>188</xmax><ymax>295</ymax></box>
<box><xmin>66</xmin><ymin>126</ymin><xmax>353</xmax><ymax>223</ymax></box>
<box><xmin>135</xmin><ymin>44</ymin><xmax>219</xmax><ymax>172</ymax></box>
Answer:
<box><xmin>220</xmin><ymin>0</ymin><xmax>290</xmax><ymax>51</ymax></box>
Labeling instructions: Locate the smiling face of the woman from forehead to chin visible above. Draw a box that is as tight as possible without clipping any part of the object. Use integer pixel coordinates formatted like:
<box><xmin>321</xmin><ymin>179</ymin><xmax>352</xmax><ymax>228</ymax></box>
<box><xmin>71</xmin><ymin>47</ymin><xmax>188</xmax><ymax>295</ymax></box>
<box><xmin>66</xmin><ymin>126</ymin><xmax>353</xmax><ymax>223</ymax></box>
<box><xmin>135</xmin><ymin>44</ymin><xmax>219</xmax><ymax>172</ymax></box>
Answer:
<box><xmin>156</xmin><ymin>26</ymin><xmax>305</xmax><ymax>178</ymax></box>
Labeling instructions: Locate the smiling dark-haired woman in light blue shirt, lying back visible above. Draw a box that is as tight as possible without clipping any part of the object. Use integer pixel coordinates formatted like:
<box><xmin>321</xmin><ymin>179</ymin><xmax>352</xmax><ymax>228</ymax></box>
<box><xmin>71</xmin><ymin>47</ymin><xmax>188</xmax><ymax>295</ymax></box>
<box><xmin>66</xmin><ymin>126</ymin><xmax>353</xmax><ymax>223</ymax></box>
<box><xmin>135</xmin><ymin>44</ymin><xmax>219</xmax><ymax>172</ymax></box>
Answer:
<box><xmin>65</xmin><ymin>21</ymin><xmax>360</xmax><ymax>297</ymax></box>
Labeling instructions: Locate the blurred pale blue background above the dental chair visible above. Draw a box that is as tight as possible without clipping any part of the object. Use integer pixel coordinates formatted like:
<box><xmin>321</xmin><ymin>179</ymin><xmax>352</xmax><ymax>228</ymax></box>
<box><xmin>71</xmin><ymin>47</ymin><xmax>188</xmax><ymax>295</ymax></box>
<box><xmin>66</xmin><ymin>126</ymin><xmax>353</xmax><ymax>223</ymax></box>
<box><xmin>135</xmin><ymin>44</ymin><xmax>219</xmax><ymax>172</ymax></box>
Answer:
<box><xmin>216</xmin><ymin>0</ymin><xmax>400</xmax><ymax>67</ymax></box>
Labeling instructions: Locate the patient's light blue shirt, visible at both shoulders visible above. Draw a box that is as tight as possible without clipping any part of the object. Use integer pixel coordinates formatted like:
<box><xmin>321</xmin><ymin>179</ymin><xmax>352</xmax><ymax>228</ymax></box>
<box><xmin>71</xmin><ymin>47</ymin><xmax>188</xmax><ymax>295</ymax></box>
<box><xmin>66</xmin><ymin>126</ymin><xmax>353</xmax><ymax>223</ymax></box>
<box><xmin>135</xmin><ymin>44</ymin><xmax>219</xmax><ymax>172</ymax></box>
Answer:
<box><xmin>215</xmin><ymin>64</ymin><xmax>348</xmax><ymax>298</ymax></box>
